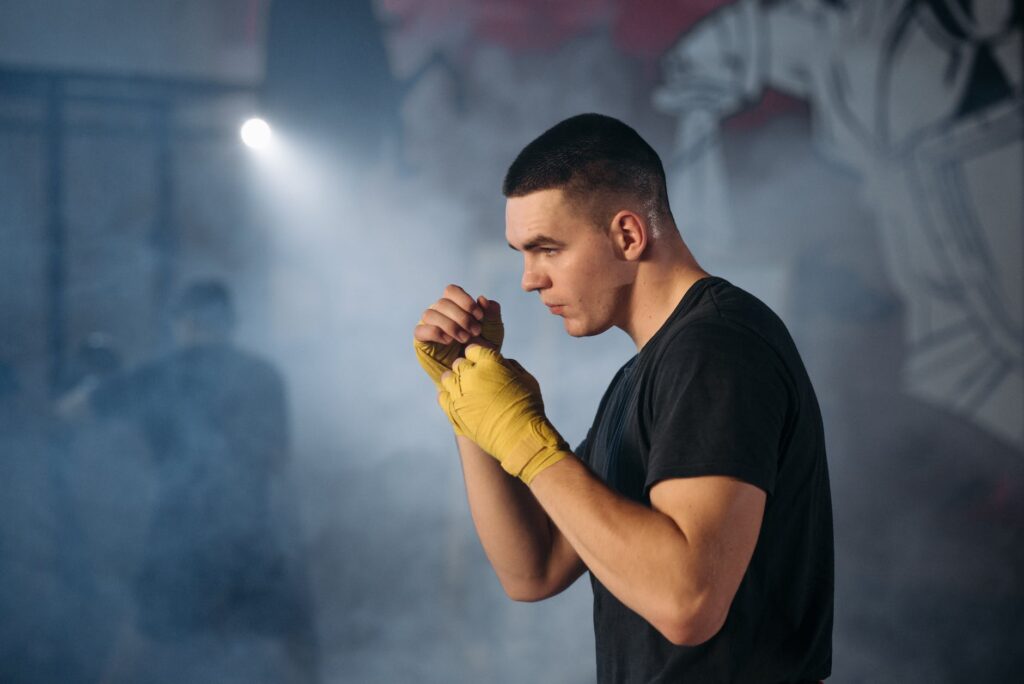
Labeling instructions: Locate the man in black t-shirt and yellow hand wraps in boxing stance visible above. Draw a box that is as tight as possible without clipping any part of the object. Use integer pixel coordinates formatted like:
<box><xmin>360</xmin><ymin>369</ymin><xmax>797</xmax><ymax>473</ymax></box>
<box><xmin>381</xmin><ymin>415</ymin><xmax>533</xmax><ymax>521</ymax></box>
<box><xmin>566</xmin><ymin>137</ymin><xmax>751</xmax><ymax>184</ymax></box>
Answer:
<box><xmin>414</xmin><ymin>115</ymin><xmax>833</xmax><ymax>684</ymax></box>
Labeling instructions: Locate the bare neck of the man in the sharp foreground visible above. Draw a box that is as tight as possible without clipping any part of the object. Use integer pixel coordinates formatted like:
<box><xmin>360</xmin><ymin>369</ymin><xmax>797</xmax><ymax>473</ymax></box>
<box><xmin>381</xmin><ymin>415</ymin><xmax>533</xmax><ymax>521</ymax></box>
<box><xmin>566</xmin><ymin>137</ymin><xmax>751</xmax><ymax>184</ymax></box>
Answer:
<box><xmin>622</xmin><ymin>239</ymin><xmax>710</xmax><ymax>351</ymax></box>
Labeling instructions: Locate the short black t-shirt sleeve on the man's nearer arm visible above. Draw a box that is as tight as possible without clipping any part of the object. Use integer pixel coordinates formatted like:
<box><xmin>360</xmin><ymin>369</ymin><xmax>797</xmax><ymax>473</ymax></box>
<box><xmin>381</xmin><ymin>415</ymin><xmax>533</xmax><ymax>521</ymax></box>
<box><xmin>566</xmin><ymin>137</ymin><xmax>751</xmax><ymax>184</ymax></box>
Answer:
<box><xmin>644</xmin><ymin>319</ymin><xmax>795</xmax><ymax>495</ymax></box>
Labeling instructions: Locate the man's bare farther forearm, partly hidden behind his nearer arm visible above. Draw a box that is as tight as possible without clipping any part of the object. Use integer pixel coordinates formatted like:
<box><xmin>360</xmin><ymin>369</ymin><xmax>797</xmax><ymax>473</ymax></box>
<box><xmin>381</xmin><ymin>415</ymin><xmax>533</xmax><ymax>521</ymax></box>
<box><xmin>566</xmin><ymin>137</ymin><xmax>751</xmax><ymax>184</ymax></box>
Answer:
<box><xmin>456</xmin><ymin>436</ymin><xmax>584</xmax><ymax>601</ymax></box>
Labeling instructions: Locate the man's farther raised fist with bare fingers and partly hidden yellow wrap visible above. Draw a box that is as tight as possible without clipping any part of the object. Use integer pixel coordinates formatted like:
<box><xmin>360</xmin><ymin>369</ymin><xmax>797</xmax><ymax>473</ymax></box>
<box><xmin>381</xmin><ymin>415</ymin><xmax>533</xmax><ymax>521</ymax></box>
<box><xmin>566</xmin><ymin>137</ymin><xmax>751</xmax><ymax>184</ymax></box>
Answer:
<box><xmin>413</xmin><ymin>285</ymin><xmax>505</xmax><ymax>389</ymax></box>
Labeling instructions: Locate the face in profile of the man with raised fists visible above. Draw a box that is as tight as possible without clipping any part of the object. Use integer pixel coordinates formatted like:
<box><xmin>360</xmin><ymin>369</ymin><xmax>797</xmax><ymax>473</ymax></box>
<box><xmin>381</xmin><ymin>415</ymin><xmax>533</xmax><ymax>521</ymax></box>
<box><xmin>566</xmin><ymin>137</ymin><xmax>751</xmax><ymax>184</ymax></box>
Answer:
<box><xmin>505</xmin><ymin>189</ymin><xmax>635</xmax><ymax>337</ymax></box>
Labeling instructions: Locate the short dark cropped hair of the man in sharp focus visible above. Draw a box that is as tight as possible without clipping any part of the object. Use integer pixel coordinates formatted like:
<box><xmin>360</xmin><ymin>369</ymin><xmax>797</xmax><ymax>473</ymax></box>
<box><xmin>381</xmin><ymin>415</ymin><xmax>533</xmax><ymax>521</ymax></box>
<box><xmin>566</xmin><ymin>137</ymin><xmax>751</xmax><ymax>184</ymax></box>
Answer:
<box><xmin>502</xmin><ymin>114</ymin><xmax>672</xmax><ymax>229</ymax></box>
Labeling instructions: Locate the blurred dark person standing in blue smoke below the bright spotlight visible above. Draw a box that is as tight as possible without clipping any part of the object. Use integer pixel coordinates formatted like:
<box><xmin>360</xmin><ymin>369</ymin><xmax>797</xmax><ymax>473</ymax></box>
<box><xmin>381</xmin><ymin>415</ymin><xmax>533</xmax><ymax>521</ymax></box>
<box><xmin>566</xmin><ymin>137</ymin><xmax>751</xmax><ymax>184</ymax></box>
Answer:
<box><xmin>89</xmin><ymin>280</ymin><xmax>317</xmax><ymax>684</ymax></box>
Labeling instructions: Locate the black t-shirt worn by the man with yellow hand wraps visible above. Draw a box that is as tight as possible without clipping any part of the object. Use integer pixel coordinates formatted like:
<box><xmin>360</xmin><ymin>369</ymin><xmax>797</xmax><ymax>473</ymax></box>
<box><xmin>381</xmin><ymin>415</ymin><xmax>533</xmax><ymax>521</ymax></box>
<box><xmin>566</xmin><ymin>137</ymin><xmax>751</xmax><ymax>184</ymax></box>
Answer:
<box><xmin>577</xmin><ymin>277</ymin><xmax>834</xmax><ymax>684</ymax></box>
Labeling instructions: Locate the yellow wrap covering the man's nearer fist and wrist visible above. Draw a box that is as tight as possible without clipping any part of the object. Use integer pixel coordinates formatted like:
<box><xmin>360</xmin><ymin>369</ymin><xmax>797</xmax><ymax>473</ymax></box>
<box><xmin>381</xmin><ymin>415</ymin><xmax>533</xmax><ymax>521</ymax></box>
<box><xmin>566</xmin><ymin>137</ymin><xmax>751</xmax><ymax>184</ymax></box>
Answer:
<box><xmin>437</xmin><ymin>345</ymin><xmax>570</xmax><ymax>484</ymax></box>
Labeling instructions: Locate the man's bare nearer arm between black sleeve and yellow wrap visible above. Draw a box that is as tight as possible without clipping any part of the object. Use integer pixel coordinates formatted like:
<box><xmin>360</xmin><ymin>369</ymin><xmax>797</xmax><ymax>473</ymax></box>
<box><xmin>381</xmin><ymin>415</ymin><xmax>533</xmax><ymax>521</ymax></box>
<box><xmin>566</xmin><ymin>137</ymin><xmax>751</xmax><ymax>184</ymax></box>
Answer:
<box><xmin>530</xmin><ymin>459</ymin><xmax>766</xmax><ymax>645</ymax></box>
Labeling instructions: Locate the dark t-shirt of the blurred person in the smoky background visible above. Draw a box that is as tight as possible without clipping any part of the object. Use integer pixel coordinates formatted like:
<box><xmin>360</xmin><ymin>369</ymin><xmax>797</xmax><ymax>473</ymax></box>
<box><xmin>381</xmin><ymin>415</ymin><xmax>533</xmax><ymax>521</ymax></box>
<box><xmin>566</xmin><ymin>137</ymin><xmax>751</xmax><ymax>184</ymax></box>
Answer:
<box><xmin>91</xmin><ymin>344</ymin><xmax>305</xmax><ymax>638</ymax></box>
